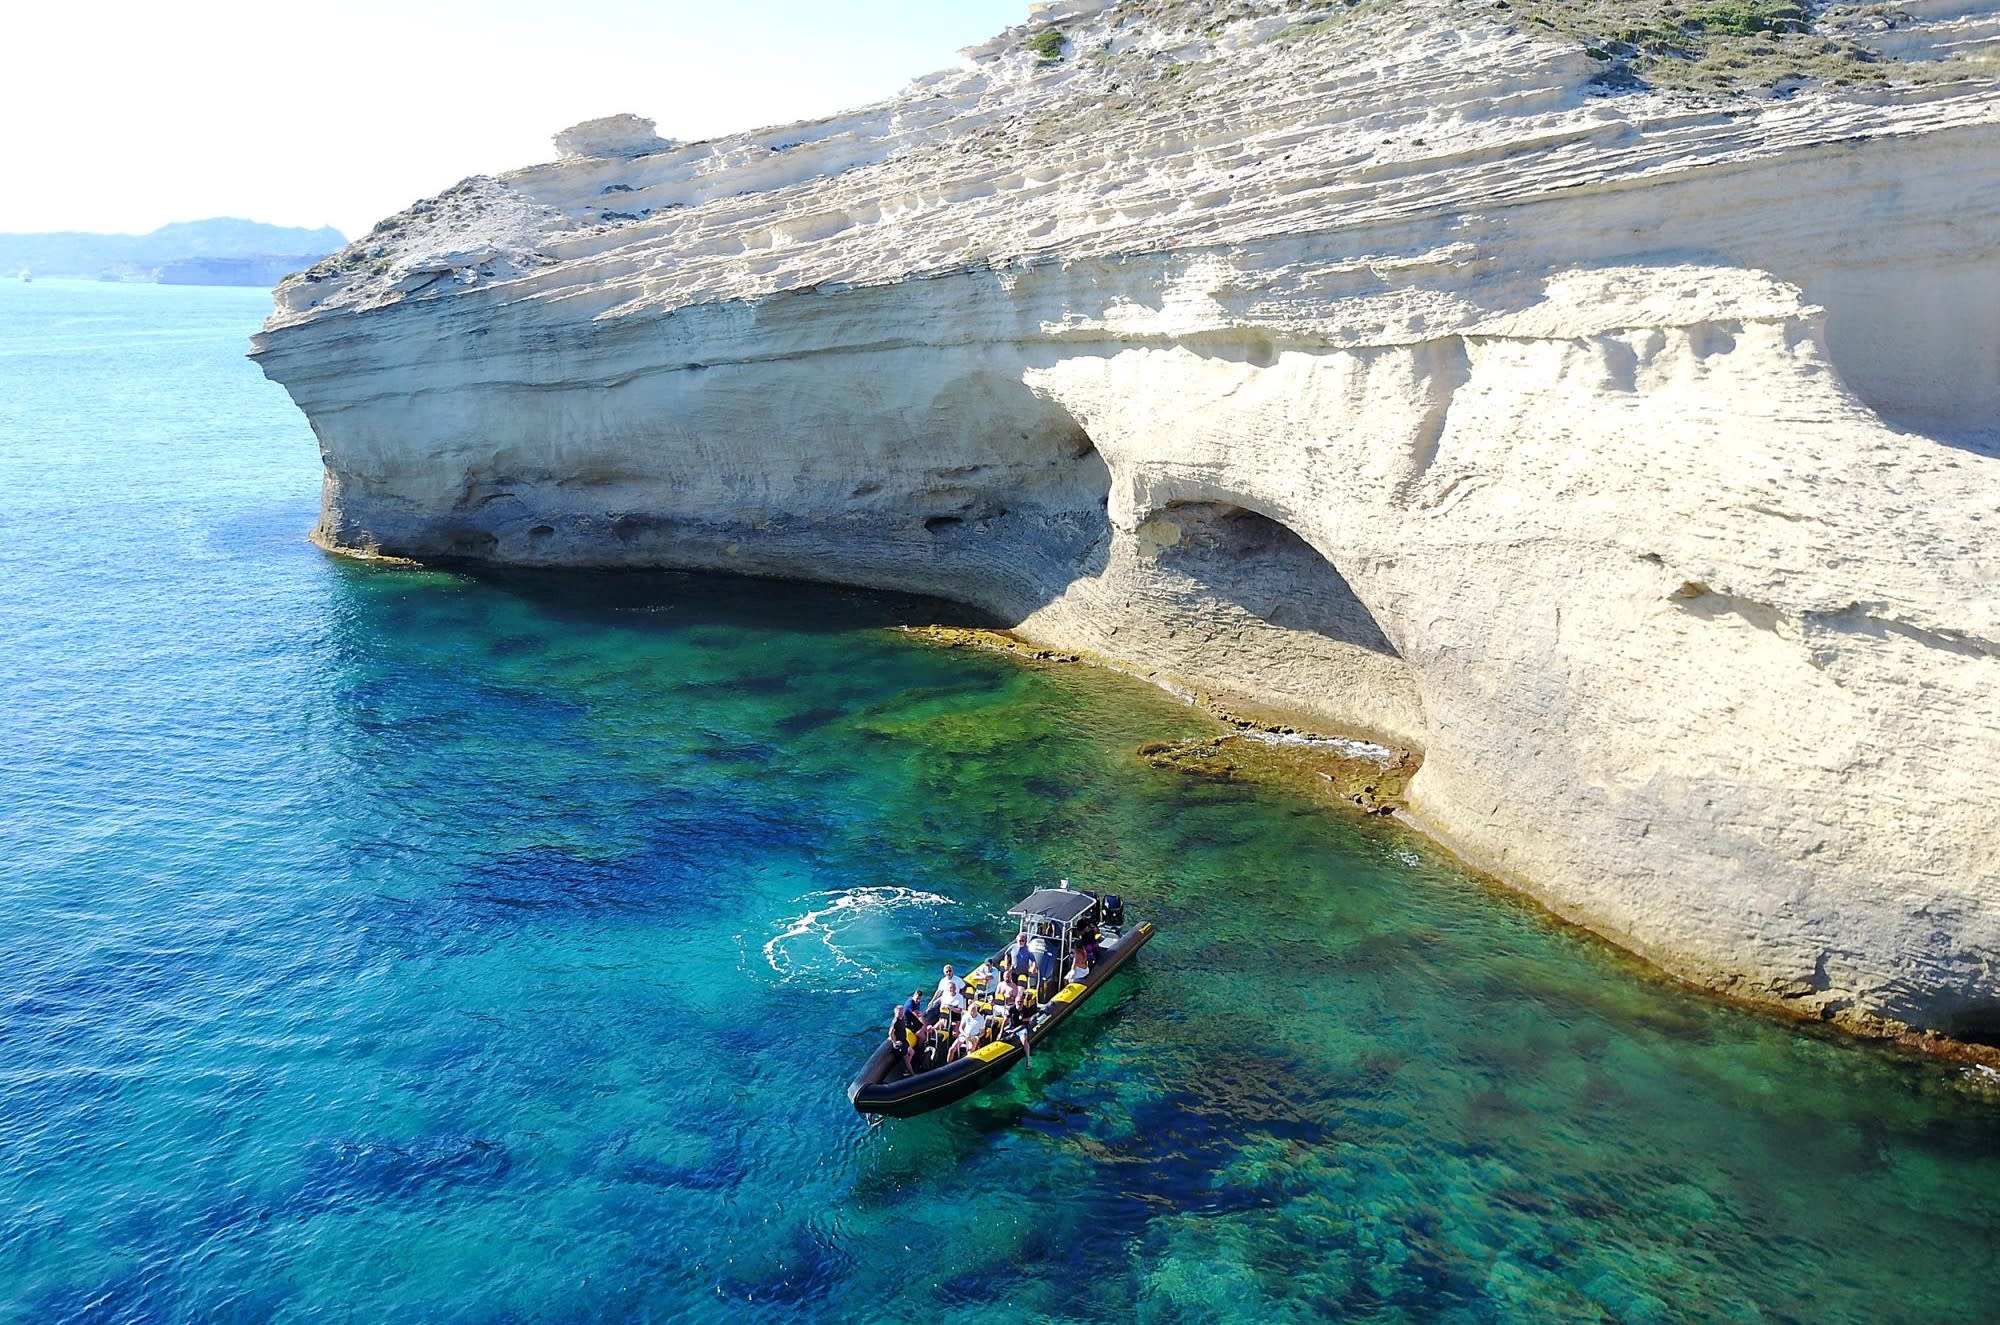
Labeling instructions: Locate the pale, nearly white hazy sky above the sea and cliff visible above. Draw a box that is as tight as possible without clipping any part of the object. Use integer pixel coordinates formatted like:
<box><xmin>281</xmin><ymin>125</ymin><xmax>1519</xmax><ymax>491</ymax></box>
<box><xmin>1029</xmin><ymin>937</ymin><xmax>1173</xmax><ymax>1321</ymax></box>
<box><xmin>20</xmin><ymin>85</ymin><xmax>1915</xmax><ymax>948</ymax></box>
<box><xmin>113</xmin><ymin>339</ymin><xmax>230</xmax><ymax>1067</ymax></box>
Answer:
<box><xmin>0</xmin><ymin>0</ymin><xmax>1028</xmax><ymax>236</ymax></box>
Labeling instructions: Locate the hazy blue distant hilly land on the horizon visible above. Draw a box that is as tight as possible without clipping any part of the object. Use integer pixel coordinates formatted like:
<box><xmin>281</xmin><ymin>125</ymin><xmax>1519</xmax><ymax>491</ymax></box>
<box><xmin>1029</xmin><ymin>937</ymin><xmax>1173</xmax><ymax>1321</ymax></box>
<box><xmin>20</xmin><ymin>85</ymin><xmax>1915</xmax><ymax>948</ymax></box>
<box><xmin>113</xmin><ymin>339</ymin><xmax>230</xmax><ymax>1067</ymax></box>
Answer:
<box><xmin>0</xmin><ymin>216</ymin><xmax>348</xmax><ymax>286</ymax></box>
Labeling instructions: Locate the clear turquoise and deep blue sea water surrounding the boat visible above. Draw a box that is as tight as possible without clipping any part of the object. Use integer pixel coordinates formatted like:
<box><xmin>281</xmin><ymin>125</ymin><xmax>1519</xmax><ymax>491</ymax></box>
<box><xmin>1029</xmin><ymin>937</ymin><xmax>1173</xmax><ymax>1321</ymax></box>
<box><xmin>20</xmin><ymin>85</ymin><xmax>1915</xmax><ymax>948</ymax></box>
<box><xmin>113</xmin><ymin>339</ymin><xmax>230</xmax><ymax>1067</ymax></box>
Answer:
<box><xmin>0</xmin><ymin>282</ymin><xmax>2000</xmax><ymax>1325</ymax></box>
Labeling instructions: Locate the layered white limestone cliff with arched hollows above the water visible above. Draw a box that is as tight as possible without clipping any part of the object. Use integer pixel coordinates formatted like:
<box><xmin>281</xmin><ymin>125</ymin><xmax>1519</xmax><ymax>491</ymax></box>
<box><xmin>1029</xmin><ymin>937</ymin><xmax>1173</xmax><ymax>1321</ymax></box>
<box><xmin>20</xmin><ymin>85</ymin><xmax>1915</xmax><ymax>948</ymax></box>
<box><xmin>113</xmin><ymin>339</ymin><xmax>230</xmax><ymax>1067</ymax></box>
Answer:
<box><xmin>256</xmin><ymin>0</ymin><xmax>2000</xmax><ymax>1039</ymax></box>
